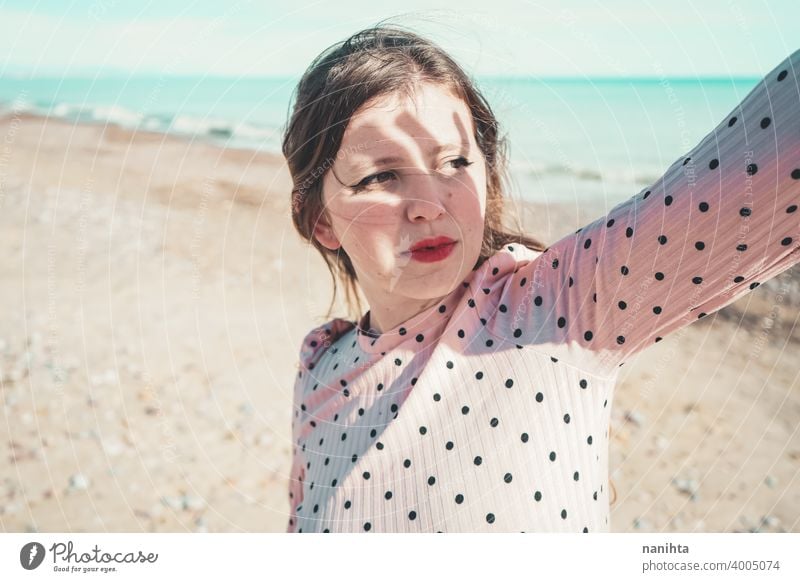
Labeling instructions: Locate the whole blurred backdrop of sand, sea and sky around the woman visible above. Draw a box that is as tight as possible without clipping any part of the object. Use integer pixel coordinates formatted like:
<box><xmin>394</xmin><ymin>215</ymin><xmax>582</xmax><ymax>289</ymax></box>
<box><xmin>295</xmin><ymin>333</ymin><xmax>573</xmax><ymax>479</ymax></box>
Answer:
<box><xmin>0</xmin><ymin>0</ymin><xmax>800</xmax><ymax>532</ymax></box>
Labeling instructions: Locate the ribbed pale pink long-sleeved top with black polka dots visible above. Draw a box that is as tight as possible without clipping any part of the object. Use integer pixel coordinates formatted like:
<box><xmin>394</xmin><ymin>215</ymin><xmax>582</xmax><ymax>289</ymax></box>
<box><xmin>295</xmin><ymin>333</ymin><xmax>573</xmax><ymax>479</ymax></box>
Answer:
<box><xmin>287</xmin><ymin>51</ymin><xmax>800</xmax><ymax>533</ymax></box>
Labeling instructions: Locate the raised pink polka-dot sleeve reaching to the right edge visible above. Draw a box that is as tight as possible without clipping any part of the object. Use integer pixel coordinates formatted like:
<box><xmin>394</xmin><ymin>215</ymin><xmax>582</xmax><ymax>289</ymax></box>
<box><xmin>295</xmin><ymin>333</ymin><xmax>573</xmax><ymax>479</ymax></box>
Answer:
<box><xmin>492</xmin><ymin>51</ymin><xmax>800</xmax><ymax>375</ymax></box>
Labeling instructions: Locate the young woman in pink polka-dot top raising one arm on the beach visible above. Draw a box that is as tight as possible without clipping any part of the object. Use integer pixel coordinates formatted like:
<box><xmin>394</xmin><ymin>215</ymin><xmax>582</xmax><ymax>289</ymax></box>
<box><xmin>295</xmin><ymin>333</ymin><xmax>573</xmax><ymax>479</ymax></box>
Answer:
<box><xmin>283</xmin><ymin>27</ymin><xmax>800</xmax><ymax>532</ymax></box>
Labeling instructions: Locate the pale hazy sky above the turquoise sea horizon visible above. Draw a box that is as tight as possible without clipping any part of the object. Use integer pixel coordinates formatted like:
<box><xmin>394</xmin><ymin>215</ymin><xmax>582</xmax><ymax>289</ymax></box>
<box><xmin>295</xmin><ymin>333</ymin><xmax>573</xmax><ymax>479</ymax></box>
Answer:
<box><xmin>0</xmin><ymin>0</ymin><xmax>800</xmax><ymax>77</ymax></box>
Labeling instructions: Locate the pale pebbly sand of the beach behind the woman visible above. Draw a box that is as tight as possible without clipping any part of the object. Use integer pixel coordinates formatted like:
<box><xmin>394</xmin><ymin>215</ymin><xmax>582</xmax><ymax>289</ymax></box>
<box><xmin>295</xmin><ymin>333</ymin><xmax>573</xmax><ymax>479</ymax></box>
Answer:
<box><xmin>0</xmin><ymin>114</ymin><xmax>800</xmax><ymax>532</ymax></box>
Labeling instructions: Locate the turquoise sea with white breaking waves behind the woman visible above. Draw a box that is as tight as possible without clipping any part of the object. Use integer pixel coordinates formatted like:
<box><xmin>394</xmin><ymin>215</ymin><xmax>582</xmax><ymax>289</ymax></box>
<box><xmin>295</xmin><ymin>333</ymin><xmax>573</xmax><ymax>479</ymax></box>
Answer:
<box><xmin>0</xmin><ymin>76</ymin><xmax>760</xmax><ymax>204</ymax></box>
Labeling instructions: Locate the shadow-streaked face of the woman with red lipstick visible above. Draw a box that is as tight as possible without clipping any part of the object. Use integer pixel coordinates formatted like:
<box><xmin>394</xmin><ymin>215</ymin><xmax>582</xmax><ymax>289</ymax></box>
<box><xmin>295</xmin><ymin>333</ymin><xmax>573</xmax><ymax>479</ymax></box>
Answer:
<box><xmin>315</xmin><ymin>83</ymin><xmax>486</xmax><ymax>307</ymax></box>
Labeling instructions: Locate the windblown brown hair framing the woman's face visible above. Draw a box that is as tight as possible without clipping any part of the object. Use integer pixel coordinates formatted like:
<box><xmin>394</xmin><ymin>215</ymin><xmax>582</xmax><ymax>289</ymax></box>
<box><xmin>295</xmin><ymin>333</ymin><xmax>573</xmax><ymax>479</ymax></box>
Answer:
<box><xmin>283</xmin><ymin>24</ymin><xmax>546</xmax><ymax>319</ymax></box>
